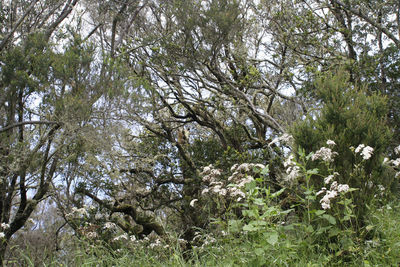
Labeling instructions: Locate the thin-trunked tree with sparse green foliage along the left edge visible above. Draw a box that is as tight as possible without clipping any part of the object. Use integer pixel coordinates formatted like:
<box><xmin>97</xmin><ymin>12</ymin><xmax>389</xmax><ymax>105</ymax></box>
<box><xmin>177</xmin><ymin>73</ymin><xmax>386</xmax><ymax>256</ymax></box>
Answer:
<box><xmin>0</xmin><ymin>1</ymin><xmax>108</xmax><ymax>261</ymax></box>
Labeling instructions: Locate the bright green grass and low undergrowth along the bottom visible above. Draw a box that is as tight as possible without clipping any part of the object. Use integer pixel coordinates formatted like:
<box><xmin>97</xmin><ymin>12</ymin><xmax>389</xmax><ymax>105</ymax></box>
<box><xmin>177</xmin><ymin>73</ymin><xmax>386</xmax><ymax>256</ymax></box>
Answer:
<box><xmin>12</xmin><ymin>201</ymin><xmax>400</xmax><ymax>266</ymax></box>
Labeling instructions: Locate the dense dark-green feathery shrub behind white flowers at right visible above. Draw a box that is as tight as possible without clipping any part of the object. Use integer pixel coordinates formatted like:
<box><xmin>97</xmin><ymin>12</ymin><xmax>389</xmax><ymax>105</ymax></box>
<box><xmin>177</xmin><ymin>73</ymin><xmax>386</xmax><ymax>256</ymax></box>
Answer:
<box><xmin>291</xmin><ymin>71</ymin><xmax>393</xmax><ymax>224</ymax></box>
